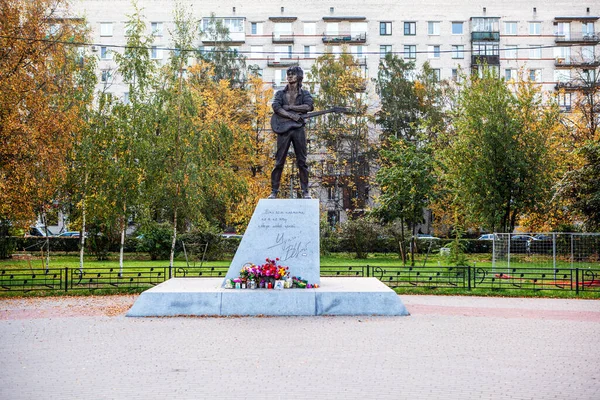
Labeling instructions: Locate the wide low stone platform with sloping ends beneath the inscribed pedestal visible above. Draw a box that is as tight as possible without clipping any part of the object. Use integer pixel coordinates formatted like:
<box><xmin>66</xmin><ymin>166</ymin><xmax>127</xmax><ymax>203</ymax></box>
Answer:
<box><xmin>127</xmin><ymin>278</ymin><xmax>409</xmax><ymax>317</ymax></box>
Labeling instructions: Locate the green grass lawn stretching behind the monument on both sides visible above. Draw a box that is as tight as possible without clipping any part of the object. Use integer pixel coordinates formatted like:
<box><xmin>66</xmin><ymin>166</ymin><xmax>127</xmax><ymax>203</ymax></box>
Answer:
<box><xmin>0</xmin><ymin>253</ymin><xmax>600</xmax><ymax>298</ymax></box>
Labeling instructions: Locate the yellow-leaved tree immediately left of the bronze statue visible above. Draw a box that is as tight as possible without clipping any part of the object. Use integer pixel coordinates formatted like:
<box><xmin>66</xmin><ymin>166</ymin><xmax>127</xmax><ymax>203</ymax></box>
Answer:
<box><xmin>189</xmin><ymin>60</ymin><xmax>252</xmax><ymax>227</ymax></box>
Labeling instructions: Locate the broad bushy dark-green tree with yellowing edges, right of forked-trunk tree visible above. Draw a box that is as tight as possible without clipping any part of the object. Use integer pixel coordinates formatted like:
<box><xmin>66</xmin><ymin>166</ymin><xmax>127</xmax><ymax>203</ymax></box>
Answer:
<box><xmin>440</xmin><ymin>69</ymin><xmax>558</xmax><ymax>232</ymax></box>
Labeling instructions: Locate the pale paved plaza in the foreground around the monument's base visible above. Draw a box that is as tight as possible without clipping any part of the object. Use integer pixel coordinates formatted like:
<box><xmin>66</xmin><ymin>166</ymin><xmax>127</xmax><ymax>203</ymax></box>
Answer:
<box><xmin>0</xmin><ymin>296</ymin><xmax>600</xmax><ymax>400</ymax></box>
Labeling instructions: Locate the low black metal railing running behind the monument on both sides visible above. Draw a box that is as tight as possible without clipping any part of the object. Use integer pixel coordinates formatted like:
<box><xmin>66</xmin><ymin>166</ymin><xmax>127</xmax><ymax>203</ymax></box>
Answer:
<box><xmin>0</xmin><ymin>265</ymin><xmax>600</xmax><ymax>294</ymax></box>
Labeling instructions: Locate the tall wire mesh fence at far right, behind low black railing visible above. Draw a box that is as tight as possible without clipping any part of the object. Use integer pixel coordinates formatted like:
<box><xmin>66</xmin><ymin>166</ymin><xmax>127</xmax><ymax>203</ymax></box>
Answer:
<box><xmin>492</xmin><ymin>233</ymin><xmax>600</xmax><ymax>276</ymax></box>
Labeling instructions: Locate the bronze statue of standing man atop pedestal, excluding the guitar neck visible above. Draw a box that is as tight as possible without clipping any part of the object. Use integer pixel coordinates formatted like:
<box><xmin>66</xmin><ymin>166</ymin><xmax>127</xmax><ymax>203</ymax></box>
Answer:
<box><xmin>269</xmin><ymin>66</ymin><xmax>314</xmax><ymax>199</ymax></box>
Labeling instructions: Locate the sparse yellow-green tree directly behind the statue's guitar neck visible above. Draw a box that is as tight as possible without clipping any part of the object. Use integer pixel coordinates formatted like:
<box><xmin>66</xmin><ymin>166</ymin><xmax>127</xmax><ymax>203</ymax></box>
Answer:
<box><xmin>306</xmin><ymin>52</ymin><xmax>375</xmax><ymax>219</ymax></box>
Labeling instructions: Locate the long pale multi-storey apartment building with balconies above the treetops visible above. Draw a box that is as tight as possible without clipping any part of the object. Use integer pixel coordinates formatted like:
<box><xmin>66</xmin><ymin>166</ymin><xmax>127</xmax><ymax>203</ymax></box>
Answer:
<box><xmin>75</xmin><ymin>0</ymin><xmax>600</xmax><ymax>106</ymax></box>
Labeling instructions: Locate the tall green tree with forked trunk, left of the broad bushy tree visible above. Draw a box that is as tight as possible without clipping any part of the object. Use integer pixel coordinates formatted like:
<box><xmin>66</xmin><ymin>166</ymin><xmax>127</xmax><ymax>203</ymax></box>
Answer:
<box><xmin>375</xmin><ymin>54</ymin><xmax>447</xmax><ymax>262</ymax></box>
